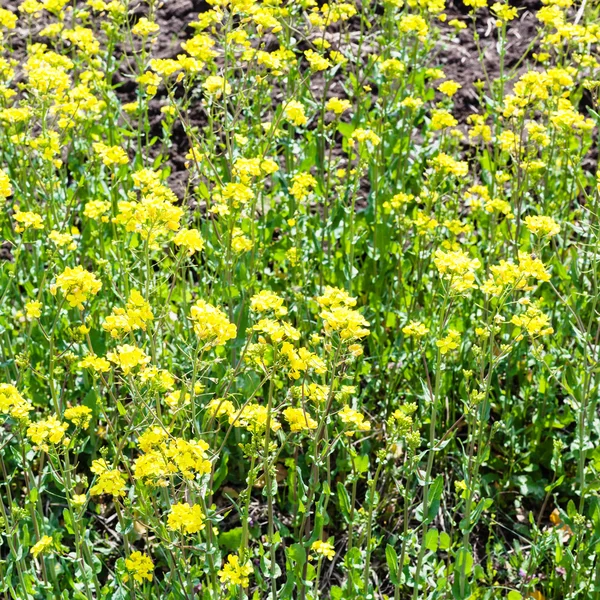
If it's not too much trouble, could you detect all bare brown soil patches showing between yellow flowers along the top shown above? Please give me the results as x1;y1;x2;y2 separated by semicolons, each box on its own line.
0;0;597;192
